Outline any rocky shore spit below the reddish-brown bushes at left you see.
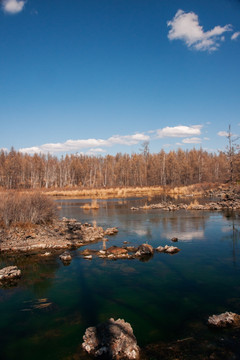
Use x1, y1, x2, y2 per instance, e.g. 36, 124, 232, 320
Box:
0, 218, 118, 252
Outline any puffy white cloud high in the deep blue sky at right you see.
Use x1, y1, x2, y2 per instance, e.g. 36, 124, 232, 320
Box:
167, 10, 232, 51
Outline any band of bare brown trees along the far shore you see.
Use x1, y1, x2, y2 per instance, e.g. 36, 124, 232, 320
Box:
0, 146, 240, 189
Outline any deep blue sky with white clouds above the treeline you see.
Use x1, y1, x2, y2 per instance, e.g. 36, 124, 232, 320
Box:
0, 0, 240, 156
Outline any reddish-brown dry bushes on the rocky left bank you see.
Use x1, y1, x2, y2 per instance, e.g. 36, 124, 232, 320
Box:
0, 191, 57, 226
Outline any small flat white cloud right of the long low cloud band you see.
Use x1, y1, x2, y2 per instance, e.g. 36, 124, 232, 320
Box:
157, 125, 202, 138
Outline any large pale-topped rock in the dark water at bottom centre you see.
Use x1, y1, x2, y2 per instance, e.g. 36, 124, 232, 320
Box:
82, 318, 139, 360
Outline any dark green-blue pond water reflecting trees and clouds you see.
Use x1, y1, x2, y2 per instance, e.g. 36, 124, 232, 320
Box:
0, 199, 240, 360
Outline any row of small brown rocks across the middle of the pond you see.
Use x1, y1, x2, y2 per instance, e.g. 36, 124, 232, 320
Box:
80, 244, 180, 260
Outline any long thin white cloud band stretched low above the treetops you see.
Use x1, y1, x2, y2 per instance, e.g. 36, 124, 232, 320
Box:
19, 133, 150, 154
